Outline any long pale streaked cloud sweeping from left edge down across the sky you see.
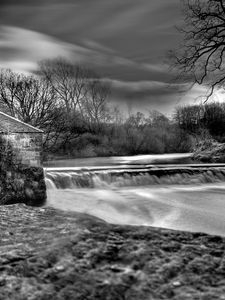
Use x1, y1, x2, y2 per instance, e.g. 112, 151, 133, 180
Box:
0, 26, 171, 78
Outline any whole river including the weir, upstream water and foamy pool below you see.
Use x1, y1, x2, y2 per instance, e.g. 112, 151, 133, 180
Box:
45, 154, 225, 236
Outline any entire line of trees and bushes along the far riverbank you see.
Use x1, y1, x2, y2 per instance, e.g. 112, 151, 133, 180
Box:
0, 59, 221, 157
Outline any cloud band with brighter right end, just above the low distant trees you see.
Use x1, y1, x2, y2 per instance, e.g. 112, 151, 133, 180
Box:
106, 79, 224, 116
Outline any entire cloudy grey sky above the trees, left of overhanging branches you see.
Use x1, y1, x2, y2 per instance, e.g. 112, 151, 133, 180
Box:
0, 0, 222, 115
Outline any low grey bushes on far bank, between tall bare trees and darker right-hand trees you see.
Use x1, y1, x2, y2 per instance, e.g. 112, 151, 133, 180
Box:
72, 111, 192, 156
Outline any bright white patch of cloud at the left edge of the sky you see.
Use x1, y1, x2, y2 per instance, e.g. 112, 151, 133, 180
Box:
0, 26, 72, 72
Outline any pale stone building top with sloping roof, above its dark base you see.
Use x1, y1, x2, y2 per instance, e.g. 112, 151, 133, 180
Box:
0, 112, 44, 166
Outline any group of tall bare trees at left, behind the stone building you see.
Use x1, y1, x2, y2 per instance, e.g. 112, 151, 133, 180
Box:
0, 59, 110, 157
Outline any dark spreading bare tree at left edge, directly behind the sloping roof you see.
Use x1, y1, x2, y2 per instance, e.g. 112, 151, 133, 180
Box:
0, 70, 66, 148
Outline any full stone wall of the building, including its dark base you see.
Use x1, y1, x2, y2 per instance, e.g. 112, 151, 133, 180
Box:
0, 133, 46, 206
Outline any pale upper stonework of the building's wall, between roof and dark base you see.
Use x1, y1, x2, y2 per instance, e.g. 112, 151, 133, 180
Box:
2, 133, 42, 166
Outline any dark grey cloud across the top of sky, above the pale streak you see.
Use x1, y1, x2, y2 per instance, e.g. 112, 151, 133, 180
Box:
1, 0, 179, 62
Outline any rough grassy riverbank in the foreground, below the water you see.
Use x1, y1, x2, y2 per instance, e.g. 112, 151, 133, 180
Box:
0, 204, 225, 300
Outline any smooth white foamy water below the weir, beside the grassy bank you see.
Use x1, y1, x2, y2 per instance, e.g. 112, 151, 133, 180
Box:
47, 185, 225, 236
